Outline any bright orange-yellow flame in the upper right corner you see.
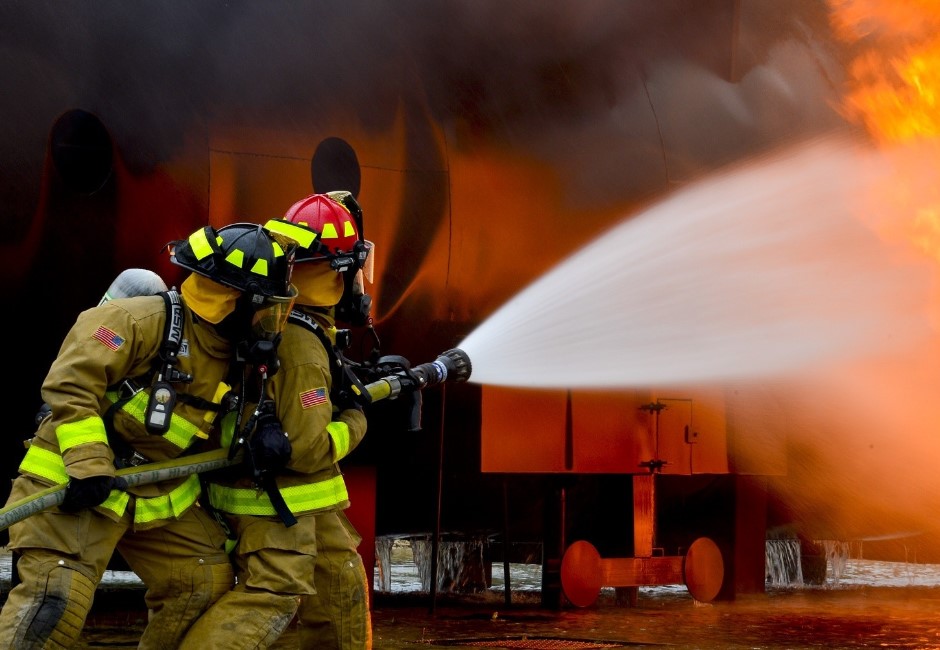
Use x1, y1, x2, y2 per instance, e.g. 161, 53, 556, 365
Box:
829, 0, 940, 261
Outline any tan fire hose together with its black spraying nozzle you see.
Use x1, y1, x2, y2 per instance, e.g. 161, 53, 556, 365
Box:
0, 348, 471, 530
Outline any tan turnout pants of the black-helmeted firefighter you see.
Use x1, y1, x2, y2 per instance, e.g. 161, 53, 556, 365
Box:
0, 470, 233, 650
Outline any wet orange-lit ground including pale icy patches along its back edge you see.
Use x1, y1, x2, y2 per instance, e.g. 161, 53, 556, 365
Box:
0, 557, 940, 650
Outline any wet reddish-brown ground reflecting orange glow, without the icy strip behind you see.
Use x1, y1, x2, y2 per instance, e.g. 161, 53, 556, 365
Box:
70, 587, 940, 650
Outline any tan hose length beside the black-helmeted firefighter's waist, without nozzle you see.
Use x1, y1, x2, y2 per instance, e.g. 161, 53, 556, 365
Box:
0, 449, 242, 530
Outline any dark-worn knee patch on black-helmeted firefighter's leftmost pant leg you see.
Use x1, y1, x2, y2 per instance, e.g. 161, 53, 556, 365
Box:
22, 565, 96, 648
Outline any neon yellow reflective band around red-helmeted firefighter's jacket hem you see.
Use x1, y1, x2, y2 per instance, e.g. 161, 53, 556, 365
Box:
209, 475, 349, 516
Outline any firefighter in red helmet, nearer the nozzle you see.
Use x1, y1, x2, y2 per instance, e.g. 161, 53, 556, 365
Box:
182, 192, 372, 650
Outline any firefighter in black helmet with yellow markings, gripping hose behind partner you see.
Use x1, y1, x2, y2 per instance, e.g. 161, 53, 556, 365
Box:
0, 224, 296, 649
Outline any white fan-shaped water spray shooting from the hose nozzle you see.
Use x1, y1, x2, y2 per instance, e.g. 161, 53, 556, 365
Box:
458, 136, 929, 388
